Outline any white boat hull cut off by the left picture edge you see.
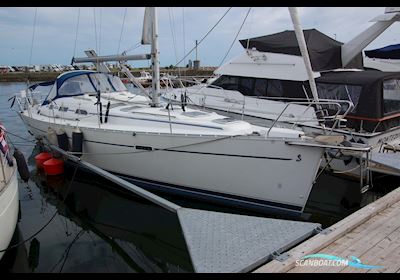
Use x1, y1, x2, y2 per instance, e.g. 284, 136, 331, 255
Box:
0, 122, 19, 259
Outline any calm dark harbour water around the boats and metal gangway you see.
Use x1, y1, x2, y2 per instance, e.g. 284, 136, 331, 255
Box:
0, 83, 396, 272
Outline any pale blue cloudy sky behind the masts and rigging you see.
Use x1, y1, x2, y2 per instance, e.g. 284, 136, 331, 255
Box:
0, 7, 400, 67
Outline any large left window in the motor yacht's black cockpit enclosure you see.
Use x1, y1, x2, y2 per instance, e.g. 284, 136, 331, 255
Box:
317, 83, 362, 114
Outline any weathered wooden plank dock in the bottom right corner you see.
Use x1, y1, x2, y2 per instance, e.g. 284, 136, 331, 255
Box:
255, 187, 400, 273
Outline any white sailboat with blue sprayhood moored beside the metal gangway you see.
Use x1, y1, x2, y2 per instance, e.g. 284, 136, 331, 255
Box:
18, 8, 354, 213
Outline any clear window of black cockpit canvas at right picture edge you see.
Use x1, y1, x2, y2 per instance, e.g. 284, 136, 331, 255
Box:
383, 79, 400, 115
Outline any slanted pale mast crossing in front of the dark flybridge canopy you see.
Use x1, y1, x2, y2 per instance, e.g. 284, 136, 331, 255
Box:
289, 7, 319, 104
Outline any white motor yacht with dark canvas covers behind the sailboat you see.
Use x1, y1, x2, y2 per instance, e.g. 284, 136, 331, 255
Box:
163, 8, 400, 177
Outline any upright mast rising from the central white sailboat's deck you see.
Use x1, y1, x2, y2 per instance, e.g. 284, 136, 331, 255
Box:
151, 7, 160, 107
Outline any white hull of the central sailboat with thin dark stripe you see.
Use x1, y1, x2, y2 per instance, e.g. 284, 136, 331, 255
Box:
21, 114, 322, 212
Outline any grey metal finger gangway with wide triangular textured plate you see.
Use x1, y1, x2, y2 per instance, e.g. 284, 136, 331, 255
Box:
49, 145, 321, 273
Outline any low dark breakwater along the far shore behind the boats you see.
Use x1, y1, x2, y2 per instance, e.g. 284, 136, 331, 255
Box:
0, 67, 216, 83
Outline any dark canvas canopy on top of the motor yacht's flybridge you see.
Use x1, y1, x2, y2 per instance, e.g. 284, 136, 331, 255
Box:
239, 29, 363, 71
